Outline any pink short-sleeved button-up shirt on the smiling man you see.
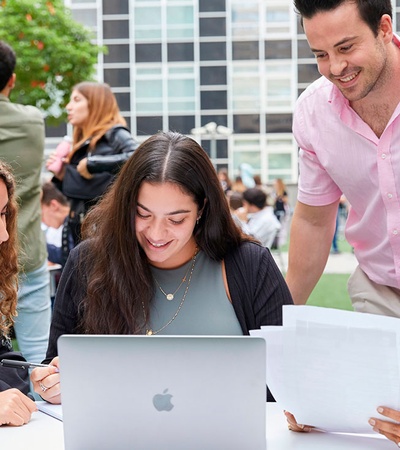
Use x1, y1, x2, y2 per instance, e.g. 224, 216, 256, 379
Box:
293, 37, 400, 288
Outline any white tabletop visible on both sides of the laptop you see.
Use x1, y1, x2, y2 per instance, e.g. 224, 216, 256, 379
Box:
0, 403, 396, 450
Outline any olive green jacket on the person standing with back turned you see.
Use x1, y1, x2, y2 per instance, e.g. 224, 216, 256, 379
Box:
0, 94, 47, 273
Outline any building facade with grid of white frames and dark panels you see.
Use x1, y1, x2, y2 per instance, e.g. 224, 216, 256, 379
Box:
54, 0, 400, 183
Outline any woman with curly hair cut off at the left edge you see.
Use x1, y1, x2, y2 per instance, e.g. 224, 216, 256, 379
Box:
0, 161, 37, 426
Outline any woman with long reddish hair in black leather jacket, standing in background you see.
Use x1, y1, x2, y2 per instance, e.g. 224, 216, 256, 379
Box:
46, 81, 137, 245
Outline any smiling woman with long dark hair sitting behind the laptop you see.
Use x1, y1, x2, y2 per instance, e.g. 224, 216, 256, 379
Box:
31, 129, 292, 403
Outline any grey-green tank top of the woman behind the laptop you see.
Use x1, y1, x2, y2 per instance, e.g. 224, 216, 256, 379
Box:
150, 251, 243, 336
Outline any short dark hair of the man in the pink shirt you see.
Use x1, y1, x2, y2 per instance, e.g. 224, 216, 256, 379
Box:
294, 0, 393, 36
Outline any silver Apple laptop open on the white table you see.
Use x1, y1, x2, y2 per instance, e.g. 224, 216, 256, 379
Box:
58, 335, 266, 450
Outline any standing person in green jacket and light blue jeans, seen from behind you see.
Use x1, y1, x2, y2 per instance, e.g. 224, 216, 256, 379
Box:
0, 42, 51, 368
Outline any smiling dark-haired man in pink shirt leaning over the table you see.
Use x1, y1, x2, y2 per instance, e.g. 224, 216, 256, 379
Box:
286, 0, 400, 317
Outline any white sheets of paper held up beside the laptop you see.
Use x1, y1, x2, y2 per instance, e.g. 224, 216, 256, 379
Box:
251, 306, 400, 433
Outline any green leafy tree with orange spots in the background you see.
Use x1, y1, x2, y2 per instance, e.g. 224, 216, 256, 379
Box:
0, 0, 105, 125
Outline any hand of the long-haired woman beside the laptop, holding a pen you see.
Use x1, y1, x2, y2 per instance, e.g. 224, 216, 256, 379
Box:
31, 356, 61, 404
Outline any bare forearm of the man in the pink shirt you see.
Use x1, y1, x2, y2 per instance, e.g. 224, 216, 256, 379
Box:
286, 200, 339, 305
